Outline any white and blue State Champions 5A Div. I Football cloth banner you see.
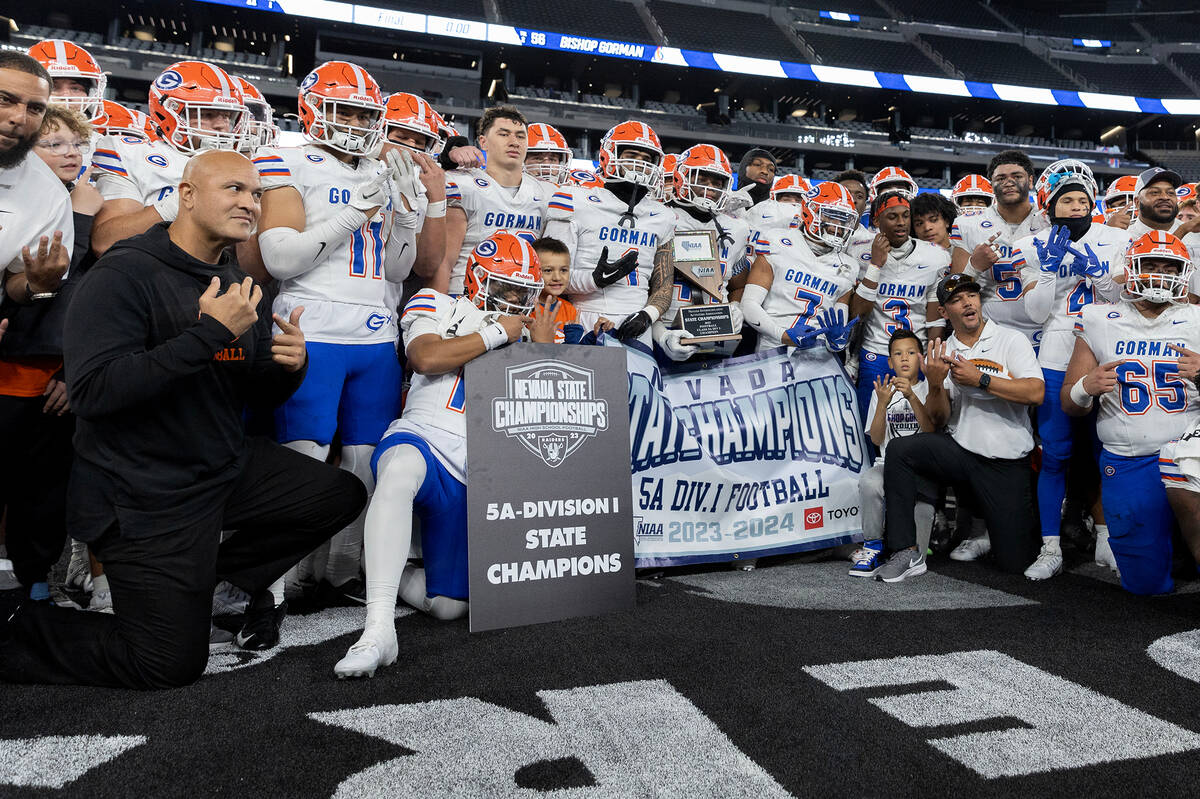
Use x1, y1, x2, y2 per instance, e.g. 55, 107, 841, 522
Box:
626, 348, 870, 567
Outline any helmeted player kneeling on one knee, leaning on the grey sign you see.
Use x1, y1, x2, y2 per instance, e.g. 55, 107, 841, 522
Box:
334, 233, 542, 679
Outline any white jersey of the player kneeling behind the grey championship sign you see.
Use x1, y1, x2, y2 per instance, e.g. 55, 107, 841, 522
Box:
388, 289, 499, 482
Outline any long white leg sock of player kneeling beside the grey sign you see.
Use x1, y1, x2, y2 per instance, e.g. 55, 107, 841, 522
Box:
362, 444, 426, 633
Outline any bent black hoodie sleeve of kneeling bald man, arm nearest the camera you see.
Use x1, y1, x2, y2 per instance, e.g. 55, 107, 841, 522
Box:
62, 269, 233, 419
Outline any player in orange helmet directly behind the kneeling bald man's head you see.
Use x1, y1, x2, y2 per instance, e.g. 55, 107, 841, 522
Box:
91, 61, 248, 253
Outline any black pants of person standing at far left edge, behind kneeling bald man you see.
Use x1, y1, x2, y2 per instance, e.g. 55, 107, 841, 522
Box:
0, 396, 74, 587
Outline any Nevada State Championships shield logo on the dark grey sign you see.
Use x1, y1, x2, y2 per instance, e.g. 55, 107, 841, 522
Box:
492, 361, 608, 467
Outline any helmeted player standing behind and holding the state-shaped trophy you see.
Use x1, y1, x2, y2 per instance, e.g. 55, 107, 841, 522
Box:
654, 144, 750, 361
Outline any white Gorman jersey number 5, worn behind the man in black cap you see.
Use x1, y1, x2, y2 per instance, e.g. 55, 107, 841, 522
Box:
950, 205, 1050, 347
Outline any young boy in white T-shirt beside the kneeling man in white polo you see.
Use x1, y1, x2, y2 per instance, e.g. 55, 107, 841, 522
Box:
850, 328, 934, 577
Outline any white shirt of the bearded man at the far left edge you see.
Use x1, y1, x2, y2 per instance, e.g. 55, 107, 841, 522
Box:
0, 152, 74, 278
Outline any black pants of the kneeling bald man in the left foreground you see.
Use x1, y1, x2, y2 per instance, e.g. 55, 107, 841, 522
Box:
0, 439, 367, 689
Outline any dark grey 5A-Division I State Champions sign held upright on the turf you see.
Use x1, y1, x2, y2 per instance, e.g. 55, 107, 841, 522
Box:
464, 343, 634, 632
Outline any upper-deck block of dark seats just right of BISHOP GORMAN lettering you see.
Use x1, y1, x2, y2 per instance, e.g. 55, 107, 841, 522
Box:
647, 0, 803, 61
